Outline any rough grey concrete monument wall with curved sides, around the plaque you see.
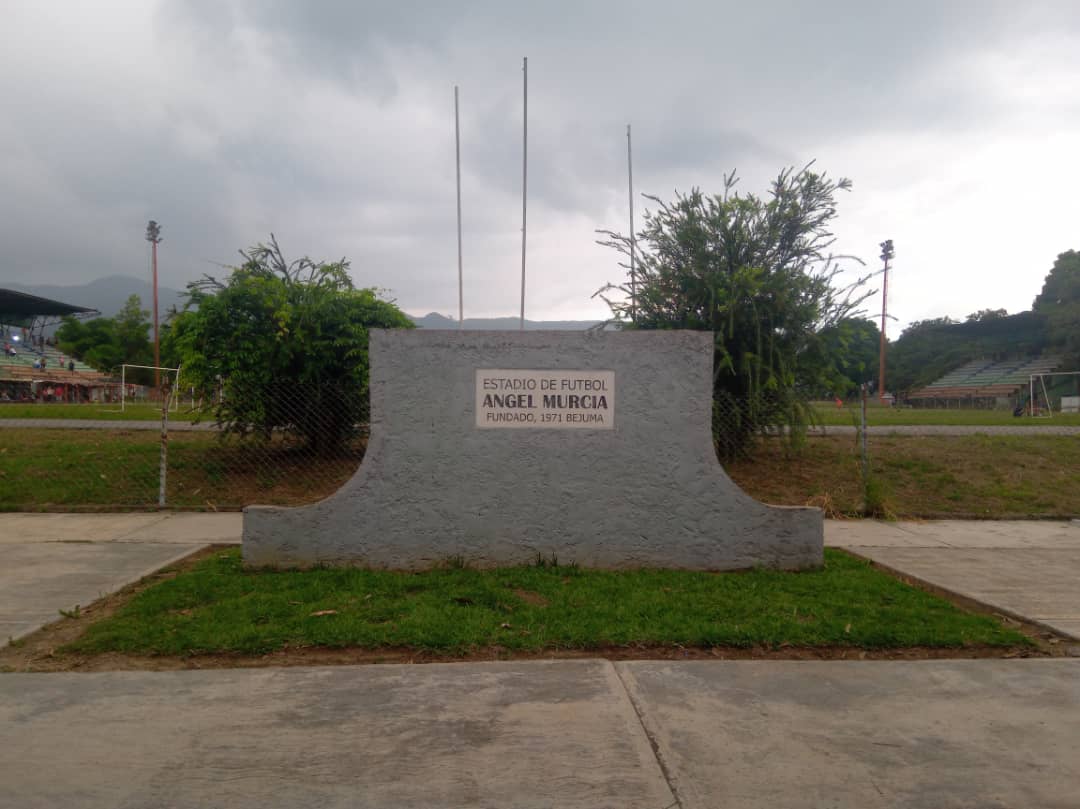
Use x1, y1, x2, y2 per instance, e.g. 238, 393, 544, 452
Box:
243, 331, 823, 570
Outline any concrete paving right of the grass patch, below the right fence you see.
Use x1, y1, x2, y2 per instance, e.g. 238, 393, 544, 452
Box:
826, 521, 1080, 639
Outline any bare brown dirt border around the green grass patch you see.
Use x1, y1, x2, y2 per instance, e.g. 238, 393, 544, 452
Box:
0, 547, 1069, 672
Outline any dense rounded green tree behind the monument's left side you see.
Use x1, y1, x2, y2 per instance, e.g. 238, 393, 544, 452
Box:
170, 235, 413, 451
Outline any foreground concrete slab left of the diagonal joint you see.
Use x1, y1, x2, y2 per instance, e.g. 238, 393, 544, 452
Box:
0, 661, 674, 809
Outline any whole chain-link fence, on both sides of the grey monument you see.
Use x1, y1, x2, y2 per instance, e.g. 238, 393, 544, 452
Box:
0, 381, 1080, 517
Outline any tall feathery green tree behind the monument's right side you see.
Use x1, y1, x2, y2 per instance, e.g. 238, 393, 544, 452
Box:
598, 166, 869, 455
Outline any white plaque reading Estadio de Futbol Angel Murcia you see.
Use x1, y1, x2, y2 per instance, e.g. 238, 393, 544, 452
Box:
476, 368, 615, 430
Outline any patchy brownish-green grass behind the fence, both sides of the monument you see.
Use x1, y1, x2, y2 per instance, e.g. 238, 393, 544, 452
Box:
0, 428, 1080, 518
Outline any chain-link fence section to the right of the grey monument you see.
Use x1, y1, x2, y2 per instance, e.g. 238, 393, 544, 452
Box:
714, 391, 1080, 520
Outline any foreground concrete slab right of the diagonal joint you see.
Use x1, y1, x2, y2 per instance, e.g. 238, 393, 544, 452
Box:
616, 659, 1080, 809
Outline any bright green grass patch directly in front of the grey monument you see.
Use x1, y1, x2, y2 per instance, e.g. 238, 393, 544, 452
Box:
63, 549, 1030, 656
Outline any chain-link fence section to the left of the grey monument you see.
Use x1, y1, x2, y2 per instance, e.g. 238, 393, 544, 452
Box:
0, 382, 367, 510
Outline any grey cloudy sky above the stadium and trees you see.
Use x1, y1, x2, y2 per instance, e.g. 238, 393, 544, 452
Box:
0, 0, 1080, 331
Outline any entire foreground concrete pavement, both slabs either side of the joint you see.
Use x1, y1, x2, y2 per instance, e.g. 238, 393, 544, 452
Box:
0, 659, 1080, 809
